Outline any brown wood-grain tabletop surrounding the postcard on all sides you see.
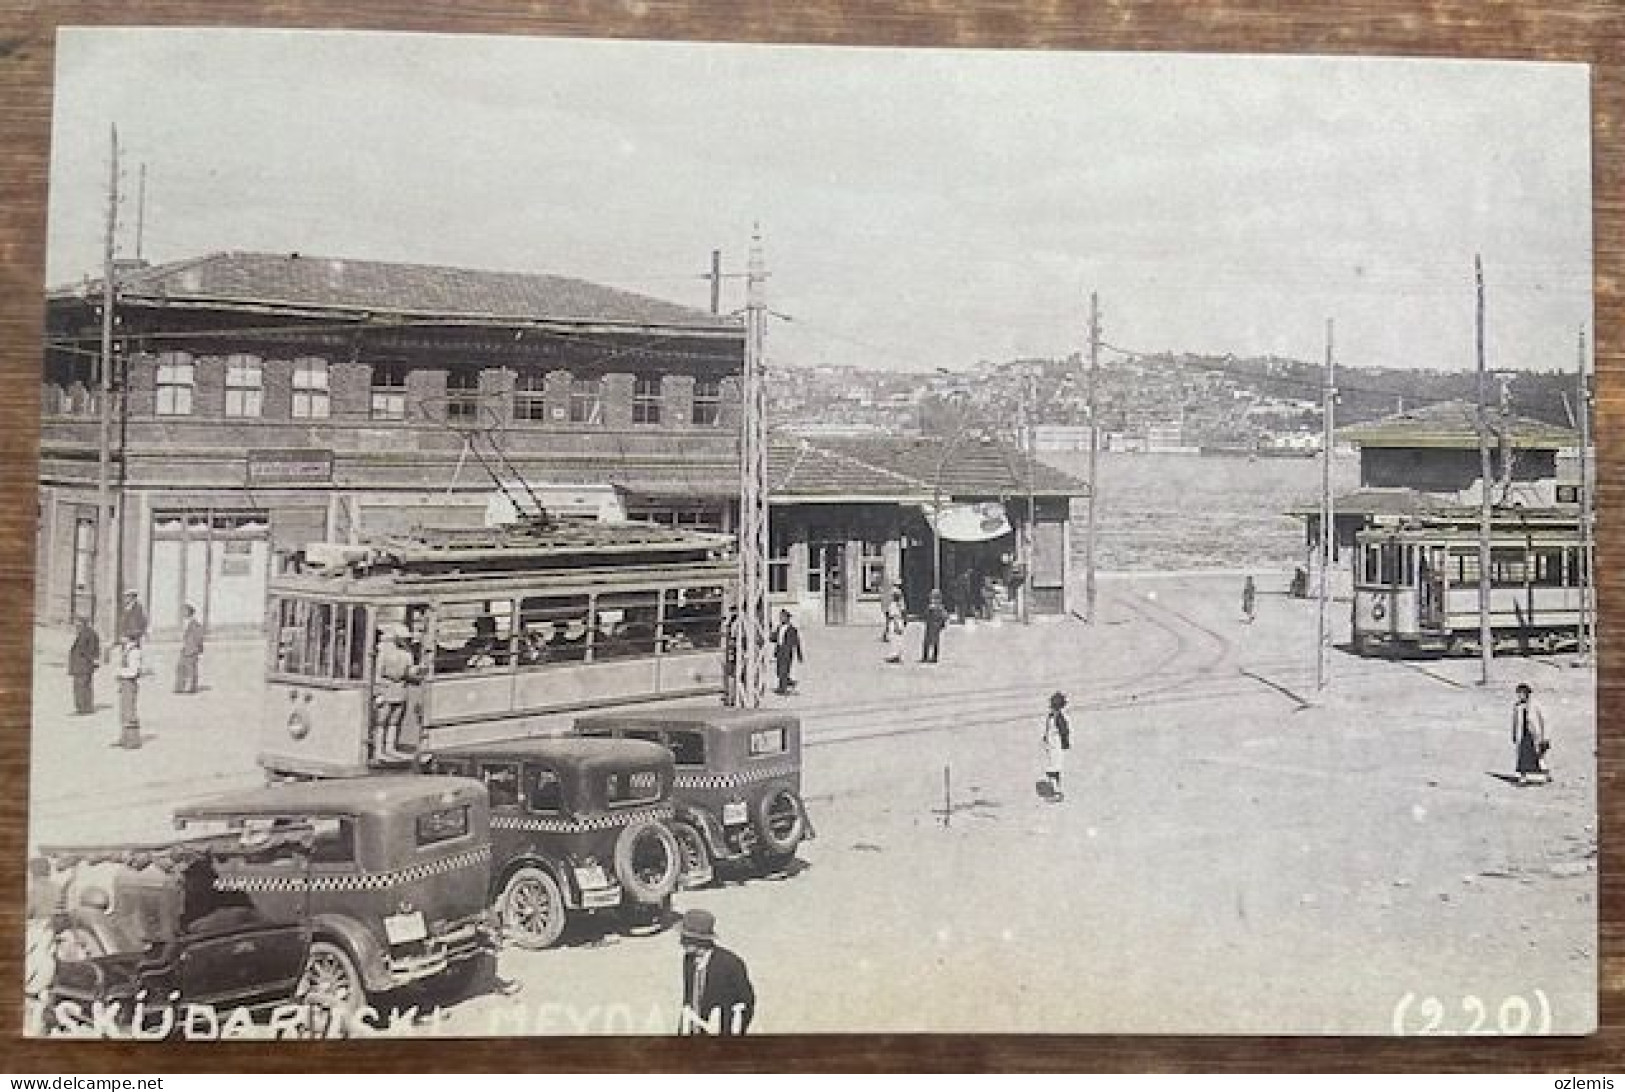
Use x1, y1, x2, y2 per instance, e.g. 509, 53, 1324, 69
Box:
0, 0, 1625, 1074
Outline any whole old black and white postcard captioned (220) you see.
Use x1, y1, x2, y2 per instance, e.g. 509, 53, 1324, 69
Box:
22, 28, 1599, 1050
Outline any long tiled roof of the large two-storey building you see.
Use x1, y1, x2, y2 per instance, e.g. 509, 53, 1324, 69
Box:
63, 252, 743, 330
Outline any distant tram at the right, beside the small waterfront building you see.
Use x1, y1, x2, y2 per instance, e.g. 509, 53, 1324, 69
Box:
1354, 512, 1588, 655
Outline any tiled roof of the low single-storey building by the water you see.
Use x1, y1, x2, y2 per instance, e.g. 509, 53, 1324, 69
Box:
767, 437, 1089, 501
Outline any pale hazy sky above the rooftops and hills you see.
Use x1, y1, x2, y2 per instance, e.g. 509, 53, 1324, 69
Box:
47, 28, 1593, 371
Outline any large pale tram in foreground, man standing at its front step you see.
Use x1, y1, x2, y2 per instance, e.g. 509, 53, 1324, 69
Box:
258, 518, 738, 777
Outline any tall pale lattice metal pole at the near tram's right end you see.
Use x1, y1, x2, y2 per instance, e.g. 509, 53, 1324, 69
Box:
734, 228, 770, 709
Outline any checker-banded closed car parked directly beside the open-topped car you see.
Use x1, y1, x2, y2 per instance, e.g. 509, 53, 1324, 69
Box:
176, 774, 494, 1011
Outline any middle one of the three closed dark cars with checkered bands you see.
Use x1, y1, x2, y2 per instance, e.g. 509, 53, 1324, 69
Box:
427, 738, 681, 949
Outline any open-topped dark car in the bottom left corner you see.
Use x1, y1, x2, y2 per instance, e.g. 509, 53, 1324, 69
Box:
28, 830, 310, 1037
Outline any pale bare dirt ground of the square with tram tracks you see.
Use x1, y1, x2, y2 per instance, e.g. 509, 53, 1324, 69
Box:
33, 575, 1597, 1035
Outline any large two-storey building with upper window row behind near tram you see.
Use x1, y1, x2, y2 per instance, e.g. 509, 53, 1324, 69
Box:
37, 254, 744, 634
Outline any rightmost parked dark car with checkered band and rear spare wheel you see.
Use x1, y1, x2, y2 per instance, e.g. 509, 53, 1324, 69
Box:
575, 707, 814, 887
